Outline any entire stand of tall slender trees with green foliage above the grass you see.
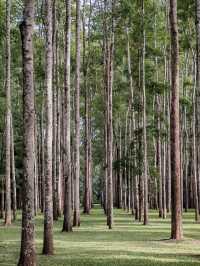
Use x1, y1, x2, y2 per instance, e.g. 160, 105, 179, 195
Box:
0, 0, 200, 265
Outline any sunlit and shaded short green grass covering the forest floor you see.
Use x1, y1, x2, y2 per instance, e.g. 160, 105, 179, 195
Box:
0, 208, 200, 266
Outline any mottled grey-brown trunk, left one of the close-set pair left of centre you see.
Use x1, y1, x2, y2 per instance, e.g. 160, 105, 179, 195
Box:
63, 0, 72, 232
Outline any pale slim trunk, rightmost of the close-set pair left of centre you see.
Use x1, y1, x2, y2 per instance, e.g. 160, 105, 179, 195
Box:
73, 0, 81, 226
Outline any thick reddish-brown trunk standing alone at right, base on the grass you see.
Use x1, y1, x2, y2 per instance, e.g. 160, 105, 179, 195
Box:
170, 0, 183, 240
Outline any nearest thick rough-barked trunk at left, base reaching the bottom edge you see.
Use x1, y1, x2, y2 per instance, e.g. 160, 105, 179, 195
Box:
18, 0, 36, 266
